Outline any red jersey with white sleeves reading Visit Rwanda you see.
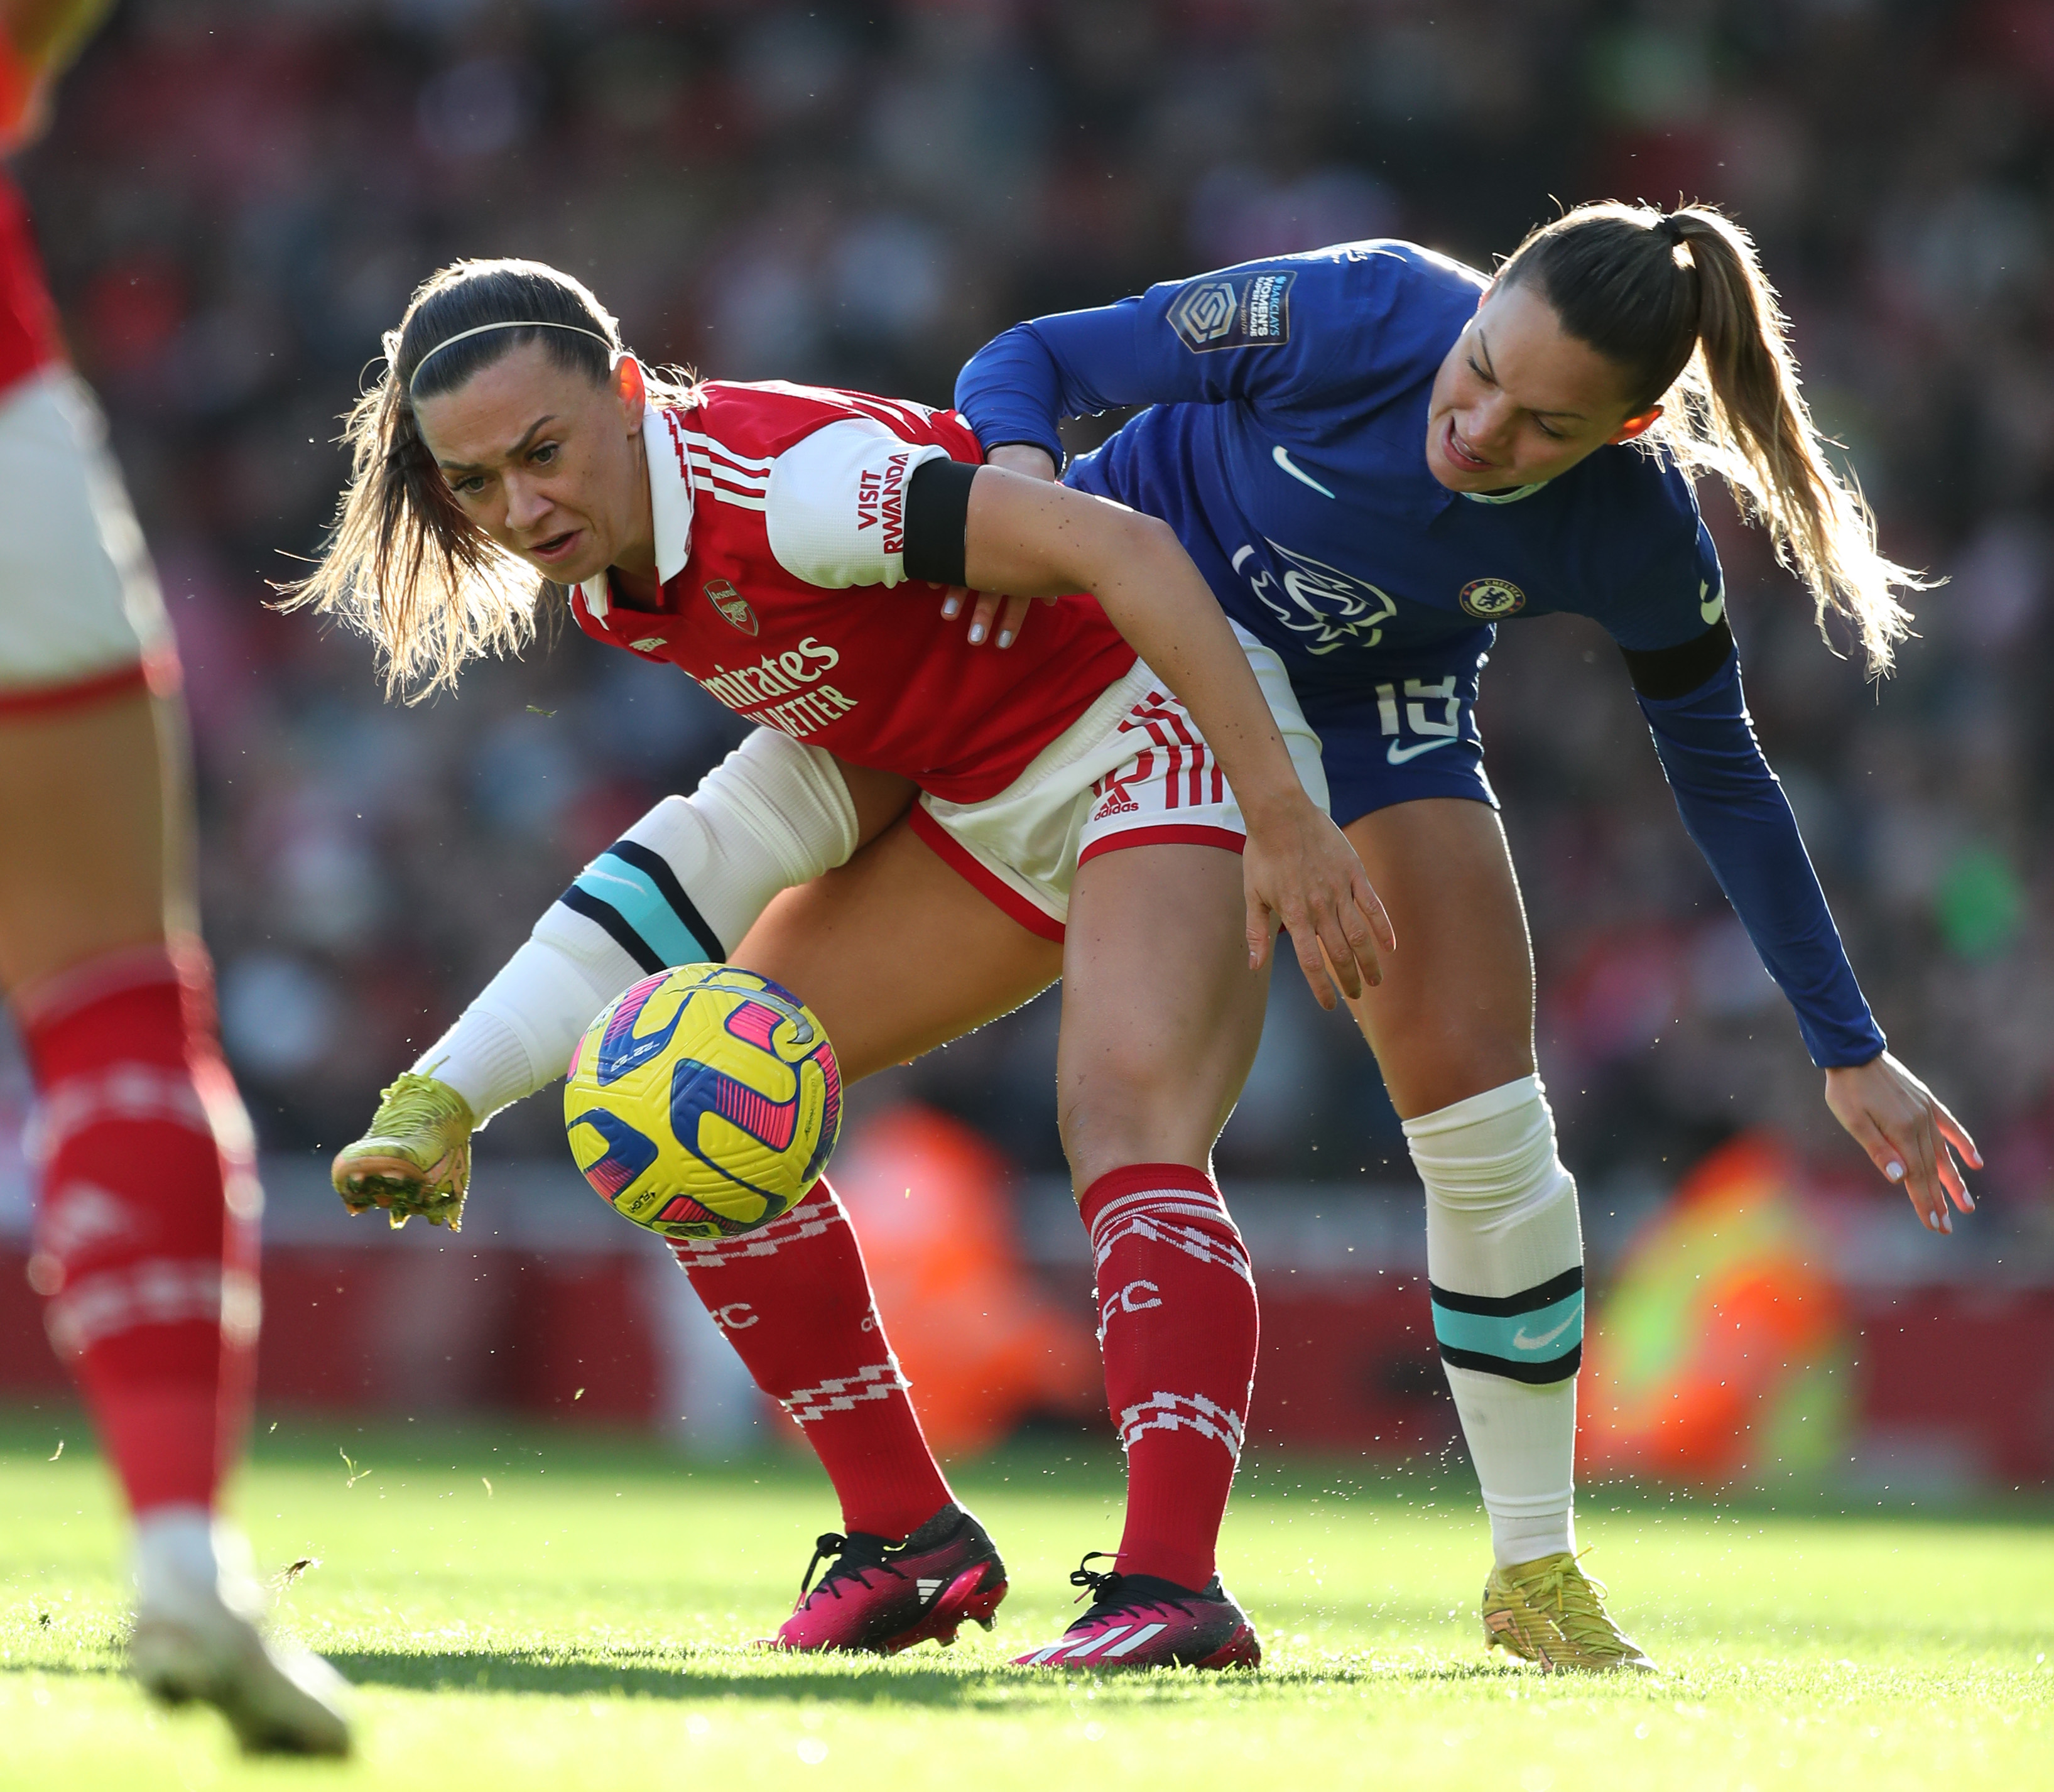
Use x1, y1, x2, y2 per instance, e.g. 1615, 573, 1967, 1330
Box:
571, 380, 1134, 803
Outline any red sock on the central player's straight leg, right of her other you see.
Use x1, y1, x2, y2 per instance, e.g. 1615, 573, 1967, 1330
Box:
1080, 1163, 1255, 1588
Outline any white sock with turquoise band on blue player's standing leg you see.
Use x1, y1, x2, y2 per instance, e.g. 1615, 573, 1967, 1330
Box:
1405, 1077, 1584, 1568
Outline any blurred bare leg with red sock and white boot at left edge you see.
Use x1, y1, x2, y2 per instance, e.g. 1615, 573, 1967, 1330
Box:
0, 682, 349, 1753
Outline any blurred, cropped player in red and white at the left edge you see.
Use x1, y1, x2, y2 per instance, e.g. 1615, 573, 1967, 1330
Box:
0, 0, 349, 1755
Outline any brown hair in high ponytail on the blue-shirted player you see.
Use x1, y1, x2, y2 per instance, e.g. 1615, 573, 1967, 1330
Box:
1497, 202, 1935, 674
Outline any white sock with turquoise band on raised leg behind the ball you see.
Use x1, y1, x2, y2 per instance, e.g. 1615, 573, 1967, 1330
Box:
413, 727, 857, 1126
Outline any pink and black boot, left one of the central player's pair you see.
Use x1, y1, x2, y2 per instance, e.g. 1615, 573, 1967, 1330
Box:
762, 1504, 1006, 1654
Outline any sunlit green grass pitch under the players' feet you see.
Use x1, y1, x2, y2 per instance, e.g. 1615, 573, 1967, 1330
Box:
0, 1414, 2054, 1792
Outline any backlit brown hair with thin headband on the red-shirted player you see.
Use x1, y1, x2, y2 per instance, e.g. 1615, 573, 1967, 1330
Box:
280, 261, 688, 701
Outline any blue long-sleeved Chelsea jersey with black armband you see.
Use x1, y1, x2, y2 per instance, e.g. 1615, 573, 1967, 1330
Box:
955, 241, 1884, 1065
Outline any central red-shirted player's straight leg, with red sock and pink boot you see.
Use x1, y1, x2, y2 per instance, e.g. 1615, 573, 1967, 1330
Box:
1021, 845, 1269, 1669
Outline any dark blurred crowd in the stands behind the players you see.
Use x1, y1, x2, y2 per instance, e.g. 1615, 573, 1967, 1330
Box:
8, 0, 2054, 1225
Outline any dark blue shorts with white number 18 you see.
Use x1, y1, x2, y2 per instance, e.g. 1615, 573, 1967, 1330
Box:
1286, 639, 1497, 828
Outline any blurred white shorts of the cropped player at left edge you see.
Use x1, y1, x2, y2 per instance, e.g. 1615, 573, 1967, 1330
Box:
0, 368, 177, 717
